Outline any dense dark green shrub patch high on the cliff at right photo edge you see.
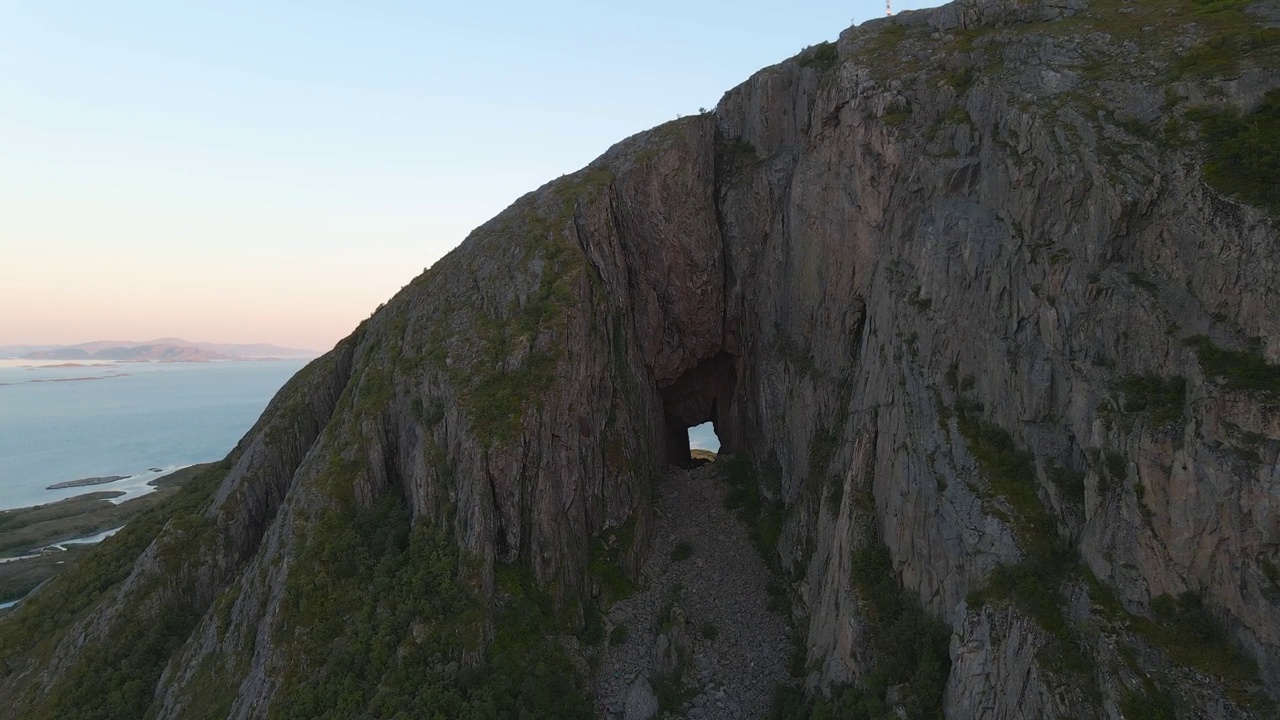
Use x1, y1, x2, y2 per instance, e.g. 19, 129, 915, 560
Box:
1188, 89, 1280, 215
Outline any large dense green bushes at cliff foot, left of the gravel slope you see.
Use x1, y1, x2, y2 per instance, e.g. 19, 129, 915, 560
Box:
269, 484, 590, 720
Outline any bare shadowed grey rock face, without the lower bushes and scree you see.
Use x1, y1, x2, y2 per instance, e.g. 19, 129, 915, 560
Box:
5, 0, 1280, 717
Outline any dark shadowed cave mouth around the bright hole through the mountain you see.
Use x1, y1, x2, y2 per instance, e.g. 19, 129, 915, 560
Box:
662, 352, 736, 468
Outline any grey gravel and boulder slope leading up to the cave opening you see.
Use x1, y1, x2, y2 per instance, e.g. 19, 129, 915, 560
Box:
595, 465, 792, 720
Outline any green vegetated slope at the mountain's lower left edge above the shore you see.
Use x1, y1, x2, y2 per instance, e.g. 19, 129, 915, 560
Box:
0, 464, 227, 720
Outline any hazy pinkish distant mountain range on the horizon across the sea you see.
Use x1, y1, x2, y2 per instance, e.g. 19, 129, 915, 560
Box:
0, 337, 320, 363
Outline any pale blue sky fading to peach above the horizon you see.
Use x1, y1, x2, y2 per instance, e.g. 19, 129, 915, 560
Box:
0, 0, 938, 348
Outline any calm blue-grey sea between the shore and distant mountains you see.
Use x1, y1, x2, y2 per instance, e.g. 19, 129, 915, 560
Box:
0, 360, 306, 510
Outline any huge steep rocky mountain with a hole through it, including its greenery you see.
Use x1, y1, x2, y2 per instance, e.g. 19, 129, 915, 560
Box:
0, 0, 1280, 719
